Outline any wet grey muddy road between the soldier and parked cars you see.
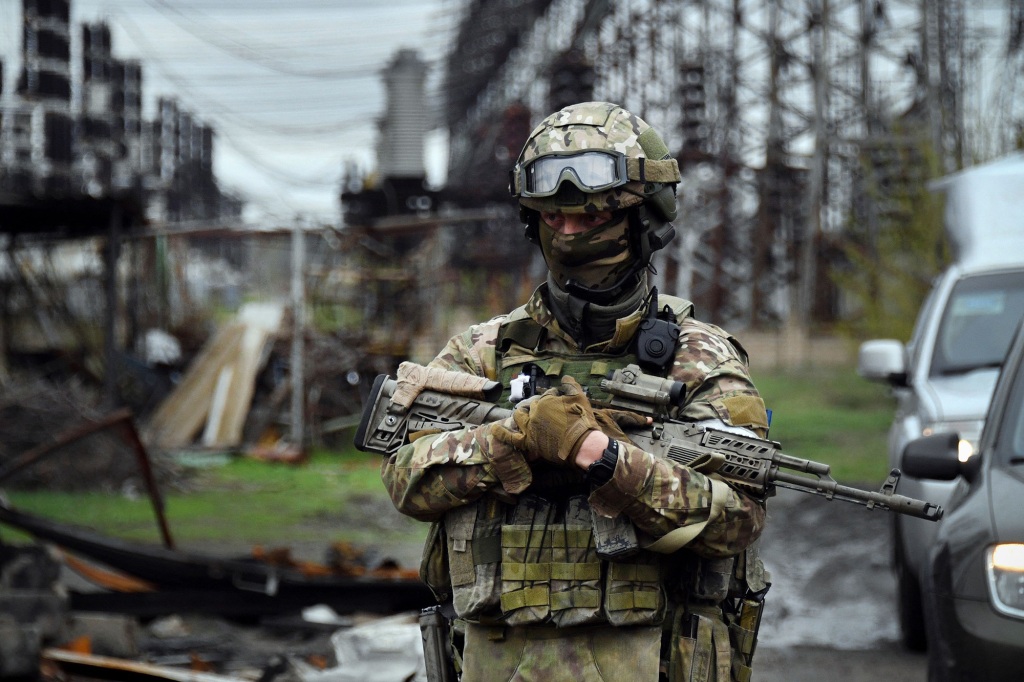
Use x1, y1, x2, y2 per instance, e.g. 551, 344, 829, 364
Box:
754, 491, 927, 682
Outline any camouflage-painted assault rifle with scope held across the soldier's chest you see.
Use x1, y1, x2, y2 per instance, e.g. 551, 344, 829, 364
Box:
355, 363, 943, 521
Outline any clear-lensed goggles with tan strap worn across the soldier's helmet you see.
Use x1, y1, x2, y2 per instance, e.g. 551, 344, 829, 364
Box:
511, 150, 679, 198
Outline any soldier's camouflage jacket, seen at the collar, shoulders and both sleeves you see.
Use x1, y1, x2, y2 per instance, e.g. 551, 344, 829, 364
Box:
381, 285, 767, 557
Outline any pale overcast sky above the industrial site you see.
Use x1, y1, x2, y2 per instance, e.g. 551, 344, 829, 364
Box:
0, 0, 462, 223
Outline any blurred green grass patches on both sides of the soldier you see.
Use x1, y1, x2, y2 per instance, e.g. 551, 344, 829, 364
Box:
4, 360, 894, 546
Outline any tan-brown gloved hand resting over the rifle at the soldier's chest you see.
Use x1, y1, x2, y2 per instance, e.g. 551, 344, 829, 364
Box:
492, 377, 601, 466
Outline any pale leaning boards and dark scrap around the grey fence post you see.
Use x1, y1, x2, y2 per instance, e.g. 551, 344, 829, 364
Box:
144, 304, 397, 459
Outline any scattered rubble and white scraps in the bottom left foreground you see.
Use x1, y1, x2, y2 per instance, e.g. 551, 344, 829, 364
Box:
0, 543, 425, 682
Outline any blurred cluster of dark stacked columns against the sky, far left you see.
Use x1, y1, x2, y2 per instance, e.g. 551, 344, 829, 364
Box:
0, 0, 239, 229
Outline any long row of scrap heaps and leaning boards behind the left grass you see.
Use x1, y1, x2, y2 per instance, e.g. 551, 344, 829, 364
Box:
0, 304, 397, 494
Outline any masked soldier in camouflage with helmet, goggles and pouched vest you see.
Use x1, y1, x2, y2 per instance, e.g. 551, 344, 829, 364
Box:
382, 102, 768, 682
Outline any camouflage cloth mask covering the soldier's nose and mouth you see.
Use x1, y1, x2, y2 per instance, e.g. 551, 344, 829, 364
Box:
538, 216, 633, 289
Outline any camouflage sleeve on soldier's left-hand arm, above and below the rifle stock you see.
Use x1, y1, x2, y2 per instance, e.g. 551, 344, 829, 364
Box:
381, 321, 532, 520
